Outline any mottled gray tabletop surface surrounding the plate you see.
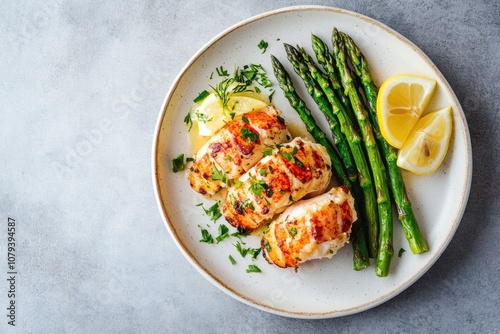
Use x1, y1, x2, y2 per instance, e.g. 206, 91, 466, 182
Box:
0, 0, 500, 333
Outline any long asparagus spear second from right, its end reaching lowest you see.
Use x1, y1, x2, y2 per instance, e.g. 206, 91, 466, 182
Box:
332, 28, 394, 277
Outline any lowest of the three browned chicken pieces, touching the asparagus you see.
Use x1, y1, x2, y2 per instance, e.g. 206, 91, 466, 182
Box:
261, 187, 357, 268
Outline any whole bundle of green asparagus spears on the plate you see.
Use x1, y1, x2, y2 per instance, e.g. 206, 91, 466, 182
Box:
271, 24, 428, 277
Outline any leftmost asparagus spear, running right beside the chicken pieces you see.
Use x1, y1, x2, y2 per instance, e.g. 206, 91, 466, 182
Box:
271, 55, 370, 270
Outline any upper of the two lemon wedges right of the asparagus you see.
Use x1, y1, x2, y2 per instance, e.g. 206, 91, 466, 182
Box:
377, 74, 436, 148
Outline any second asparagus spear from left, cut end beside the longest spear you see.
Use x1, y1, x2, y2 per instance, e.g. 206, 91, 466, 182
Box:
287, 41, 378, 257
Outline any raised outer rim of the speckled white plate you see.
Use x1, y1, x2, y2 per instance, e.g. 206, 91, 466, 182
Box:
151, 5, 472, 319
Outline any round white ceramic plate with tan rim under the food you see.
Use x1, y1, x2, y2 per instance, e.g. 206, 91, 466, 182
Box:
152, 6, 472, 318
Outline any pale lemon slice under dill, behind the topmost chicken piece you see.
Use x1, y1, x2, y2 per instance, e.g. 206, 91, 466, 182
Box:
192, 93, 267, 136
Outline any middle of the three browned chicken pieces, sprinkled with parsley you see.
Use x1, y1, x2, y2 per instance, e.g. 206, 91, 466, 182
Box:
222, 137, 332, 231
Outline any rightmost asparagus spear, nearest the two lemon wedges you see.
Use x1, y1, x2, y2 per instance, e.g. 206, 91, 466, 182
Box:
341, 33, 429, 254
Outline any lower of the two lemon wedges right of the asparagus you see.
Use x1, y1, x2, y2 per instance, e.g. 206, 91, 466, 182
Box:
397, 107, 453, 175
